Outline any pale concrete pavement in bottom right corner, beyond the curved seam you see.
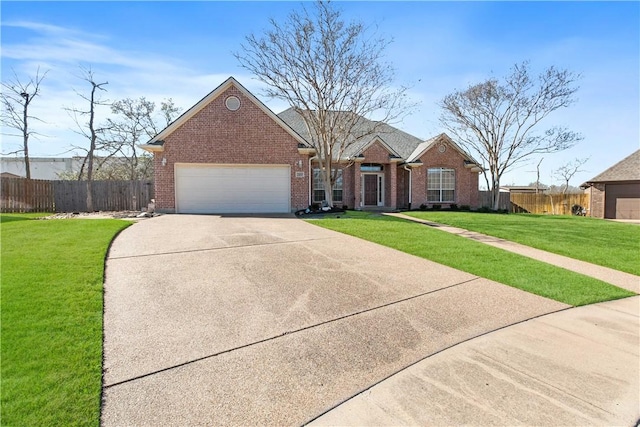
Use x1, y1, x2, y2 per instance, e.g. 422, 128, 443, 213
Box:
309, 296, 640, 426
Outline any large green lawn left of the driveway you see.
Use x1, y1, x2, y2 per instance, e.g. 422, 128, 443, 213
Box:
0, 214, 130, 426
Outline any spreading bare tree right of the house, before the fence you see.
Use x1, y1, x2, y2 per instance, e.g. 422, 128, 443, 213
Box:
440, 62, 582, 209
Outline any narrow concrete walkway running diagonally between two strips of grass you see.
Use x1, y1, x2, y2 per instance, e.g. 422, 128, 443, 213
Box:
385, 213, 640, 294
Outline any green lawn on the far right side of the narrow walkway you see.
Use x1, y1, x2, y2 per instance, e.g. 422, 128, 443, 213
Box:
407, 212, 640, 276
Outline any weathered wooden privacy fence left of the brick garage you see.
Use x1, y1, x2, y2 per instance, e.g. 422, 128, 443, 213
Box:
0, 178, 154, 212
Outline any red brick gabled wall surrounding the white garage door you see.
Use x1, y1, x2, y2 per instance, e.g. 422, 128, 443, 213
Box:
154, 86, 309, 212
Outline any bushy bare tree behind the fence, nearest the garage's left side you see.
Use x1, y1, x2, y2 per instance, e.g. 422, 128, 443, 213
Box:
105, 97, 180, 180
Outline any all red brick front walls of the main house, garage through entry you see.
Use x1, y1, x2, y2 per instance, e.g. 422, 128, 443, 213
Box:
145, 79, 478, 212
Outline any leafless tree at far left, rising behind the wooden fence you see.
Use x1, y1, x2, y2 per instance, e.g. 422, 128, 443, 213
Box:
0, 67, 48, 179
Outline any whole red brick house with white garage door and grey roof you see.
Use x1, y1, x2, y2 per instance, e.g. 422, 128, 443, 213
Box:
141, 77, 481, 213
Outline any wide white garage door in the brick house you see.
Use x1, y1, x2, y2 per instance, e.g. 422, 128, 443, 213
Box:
175, 164, 291, 213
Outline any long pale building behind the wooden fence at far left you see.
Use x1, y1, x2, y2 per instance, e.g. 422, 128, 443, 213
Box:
0, 157, 82, 180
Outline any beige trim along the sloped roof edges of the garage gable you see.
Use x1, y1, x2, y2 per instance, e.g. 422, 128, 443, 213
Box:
140, 77, 309, 151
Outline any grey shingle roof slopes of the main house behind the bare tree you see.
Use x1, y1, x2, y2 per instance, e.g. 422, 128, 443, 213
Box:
278, 108, 422, 159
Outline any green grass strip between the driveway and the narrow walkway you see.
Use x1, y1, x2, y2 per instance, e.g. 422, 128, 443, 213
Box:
309, 211, 635, 306
